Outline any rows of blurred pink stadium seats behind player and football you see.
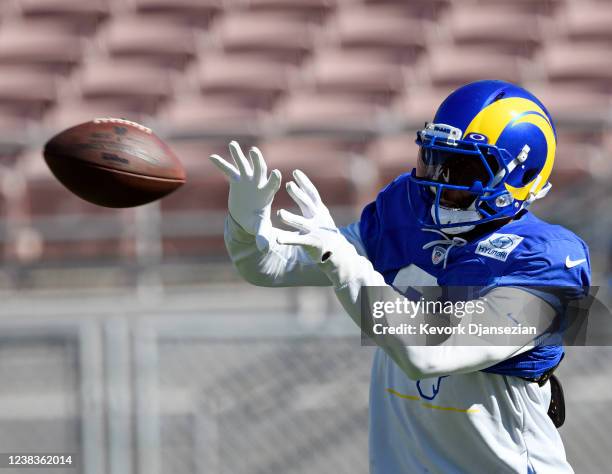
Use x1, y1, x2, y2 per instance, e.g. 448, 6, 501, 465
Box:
0, 0, 612, 262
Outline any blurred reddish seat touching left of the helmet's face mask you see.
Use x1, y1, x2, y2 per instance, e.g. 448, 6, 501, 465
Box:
366, 133, 417, 188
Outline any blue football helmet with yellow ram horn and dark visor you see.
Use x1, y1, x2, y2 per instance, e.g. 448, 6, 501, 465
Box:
410, 80, 557, 234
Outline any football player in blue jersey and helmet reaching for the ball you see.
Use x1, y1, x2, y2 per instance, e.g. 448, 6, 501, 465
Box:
211, 80, 590, 474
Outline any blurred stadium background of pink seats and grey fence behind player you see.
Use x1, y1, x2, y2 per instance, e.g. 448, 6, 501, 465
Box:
0, 0, 612, 474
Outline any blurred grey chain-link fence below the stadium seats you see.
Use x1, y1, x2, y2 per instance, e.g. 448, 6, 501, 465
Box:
0, 290, 612, 474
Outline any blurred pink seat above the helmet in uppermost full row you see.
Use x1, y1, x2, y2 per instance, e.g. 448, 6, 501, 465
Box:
443, 5, 541, 56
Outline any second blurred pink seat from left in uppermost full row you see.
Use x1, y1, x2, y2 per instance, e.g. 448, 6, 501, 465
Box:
103, 17, 196, 69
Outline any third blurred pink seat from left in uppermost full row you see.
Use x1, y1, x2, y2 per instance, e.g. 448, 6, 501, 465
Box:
213, 12, 312, 64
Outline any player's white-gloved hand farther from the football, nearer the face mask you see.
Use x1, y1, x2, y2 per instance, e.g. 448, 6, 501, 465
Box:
276, 170, 350, 263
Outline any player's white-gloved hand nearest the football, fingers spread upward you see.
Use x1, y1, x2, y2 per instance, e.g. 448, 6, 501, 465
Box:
210, 141, 281, 236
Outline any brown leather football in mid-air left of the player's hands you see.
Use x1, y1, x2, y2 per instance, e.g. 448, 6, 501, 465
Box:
44, 118, 185, 207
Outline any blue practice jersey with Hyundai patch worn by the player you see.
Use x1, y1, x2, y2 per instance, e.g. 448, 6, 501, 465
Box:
360, 175, 590, 378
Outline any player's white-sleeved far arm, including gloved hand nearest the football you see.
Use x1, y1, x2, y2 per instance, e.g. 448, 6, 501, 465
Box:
210, 141, 362, 286
